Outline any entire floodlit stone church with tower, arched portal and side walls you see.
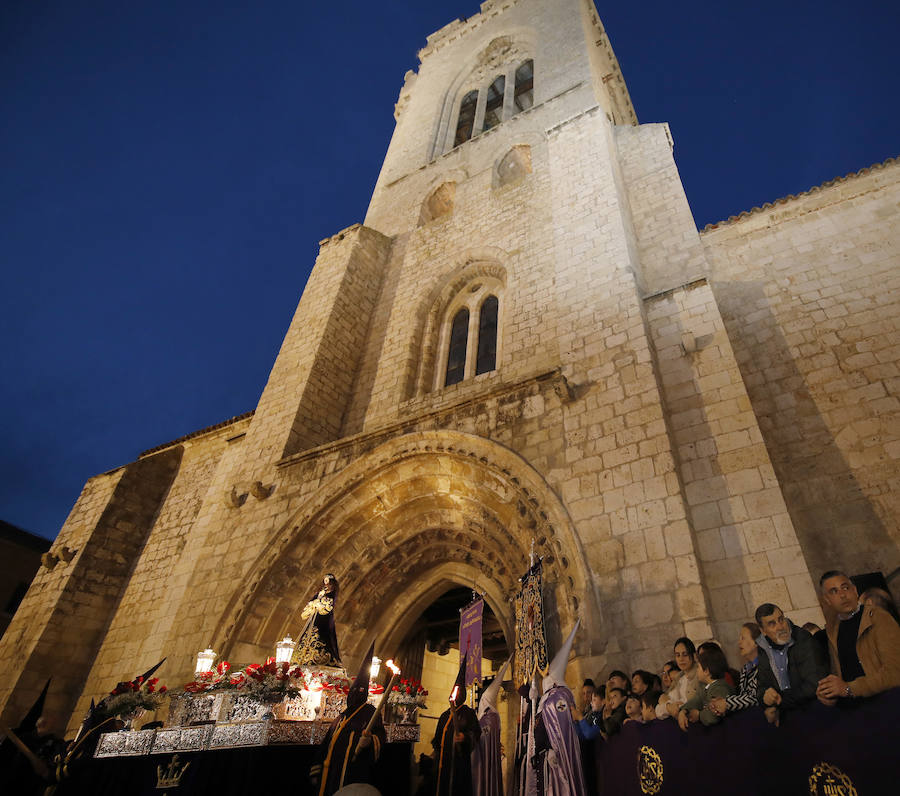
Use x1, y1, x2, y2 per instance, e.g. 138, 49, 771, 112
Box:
0, 0, 900, 726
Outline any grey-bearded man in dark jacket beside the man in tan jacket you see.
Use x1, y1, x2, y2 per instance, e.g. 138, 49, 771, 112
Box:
756, 603, 828, 724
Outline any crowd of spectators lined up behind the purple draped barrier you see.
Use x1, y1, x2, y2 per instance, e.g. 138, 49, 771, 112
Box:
574, 570, 900, 740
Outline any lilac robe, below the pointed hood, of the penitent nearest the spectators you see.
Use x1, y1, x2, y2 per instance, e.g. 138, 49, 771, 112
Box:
540, 685, 587, 796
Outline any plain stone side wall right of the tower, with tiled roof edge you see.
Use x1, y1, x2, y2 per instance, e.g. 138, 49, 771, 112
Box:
702, 160, 900, 584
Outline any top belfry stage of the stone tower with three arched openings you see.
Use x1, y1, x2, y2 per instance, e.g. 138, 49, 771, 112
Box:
366, 0, 637, 228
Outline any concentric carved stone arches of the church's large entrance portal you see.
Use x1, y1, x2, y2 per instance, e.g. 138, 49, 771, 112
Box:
216, 432, 602, 676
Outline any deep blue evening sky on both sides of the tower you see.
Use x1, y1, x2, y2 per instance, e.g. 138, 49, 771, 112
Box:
0, 0, 900, 537
